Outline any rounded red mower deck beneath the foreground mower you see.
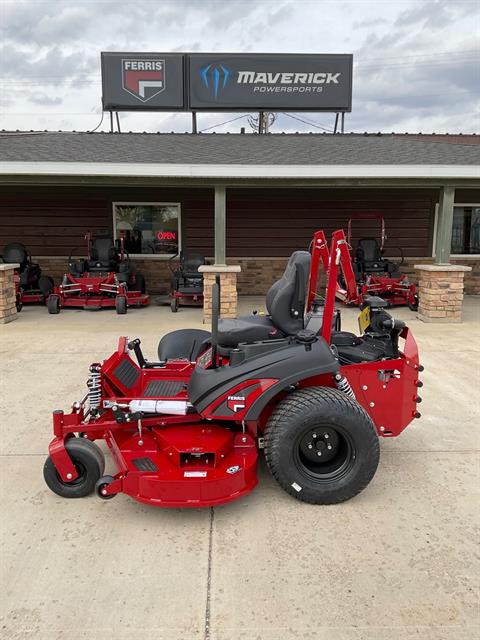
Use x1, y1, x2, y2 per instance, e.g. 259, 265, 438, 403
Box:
103, 423, 258, 507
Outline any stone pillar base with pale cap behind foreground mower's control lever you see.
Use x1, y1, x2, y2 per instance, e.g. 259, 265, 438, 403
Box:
198, 265, 240, 324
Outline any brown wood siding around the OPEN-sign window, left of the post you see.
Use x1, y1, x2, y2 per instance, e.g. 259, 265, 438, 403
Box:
0, 187, 213, 256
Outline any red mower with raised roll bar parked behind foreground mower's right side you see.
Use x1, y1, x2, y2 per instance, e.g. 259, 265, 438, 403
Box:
330, 213, 418, 311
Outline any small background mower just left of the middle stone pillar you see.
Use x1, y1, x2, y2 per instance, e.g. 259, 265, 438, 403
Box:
170, 251, 207, 313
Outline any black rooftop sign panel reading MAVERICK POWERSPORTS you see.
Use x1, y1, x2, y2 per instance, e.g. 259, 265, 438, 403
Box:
188, 53, 353, 111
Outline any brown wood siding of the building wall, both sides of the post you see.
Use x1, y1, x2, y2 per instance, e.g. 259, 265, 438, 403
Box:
0, 186, 450, 258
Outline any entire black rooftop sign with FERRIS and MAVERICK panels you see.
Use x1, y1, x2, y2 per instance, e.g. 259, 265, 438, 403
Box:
102, 53, 352, 112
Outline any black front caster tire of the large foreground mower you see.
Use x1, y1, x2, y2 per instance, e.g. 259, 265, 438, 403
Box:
43, 438, 103, 498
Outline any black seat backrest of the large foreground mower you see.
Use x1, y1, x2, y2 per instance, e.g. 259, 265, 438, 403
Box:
266, 251, 311, 335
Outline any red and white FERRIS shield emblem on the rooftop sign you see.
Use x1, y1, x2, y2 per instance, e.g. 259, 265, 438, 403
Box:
122, 58, 165, 102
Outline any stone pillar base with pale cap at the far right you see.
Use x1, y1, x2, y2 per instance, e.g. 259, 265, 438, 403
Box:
415, 264, 472, 322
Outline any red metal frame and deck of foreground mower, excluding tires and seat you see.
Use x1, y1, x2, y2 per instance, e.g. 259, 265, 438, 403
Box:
44, 231, 423, 507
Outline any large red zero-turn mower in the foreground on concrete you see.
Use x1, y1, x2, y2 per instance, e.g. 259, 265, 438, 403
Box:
44, 231, 423, 507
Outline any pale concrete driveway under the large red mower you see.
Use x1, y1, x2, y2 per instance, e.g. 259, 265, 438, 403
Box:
0, 298, 480, 640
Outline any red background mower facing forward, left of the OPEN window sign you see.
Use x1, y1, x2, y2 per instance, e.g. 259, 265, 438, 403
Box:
47, 232, 149, 314
